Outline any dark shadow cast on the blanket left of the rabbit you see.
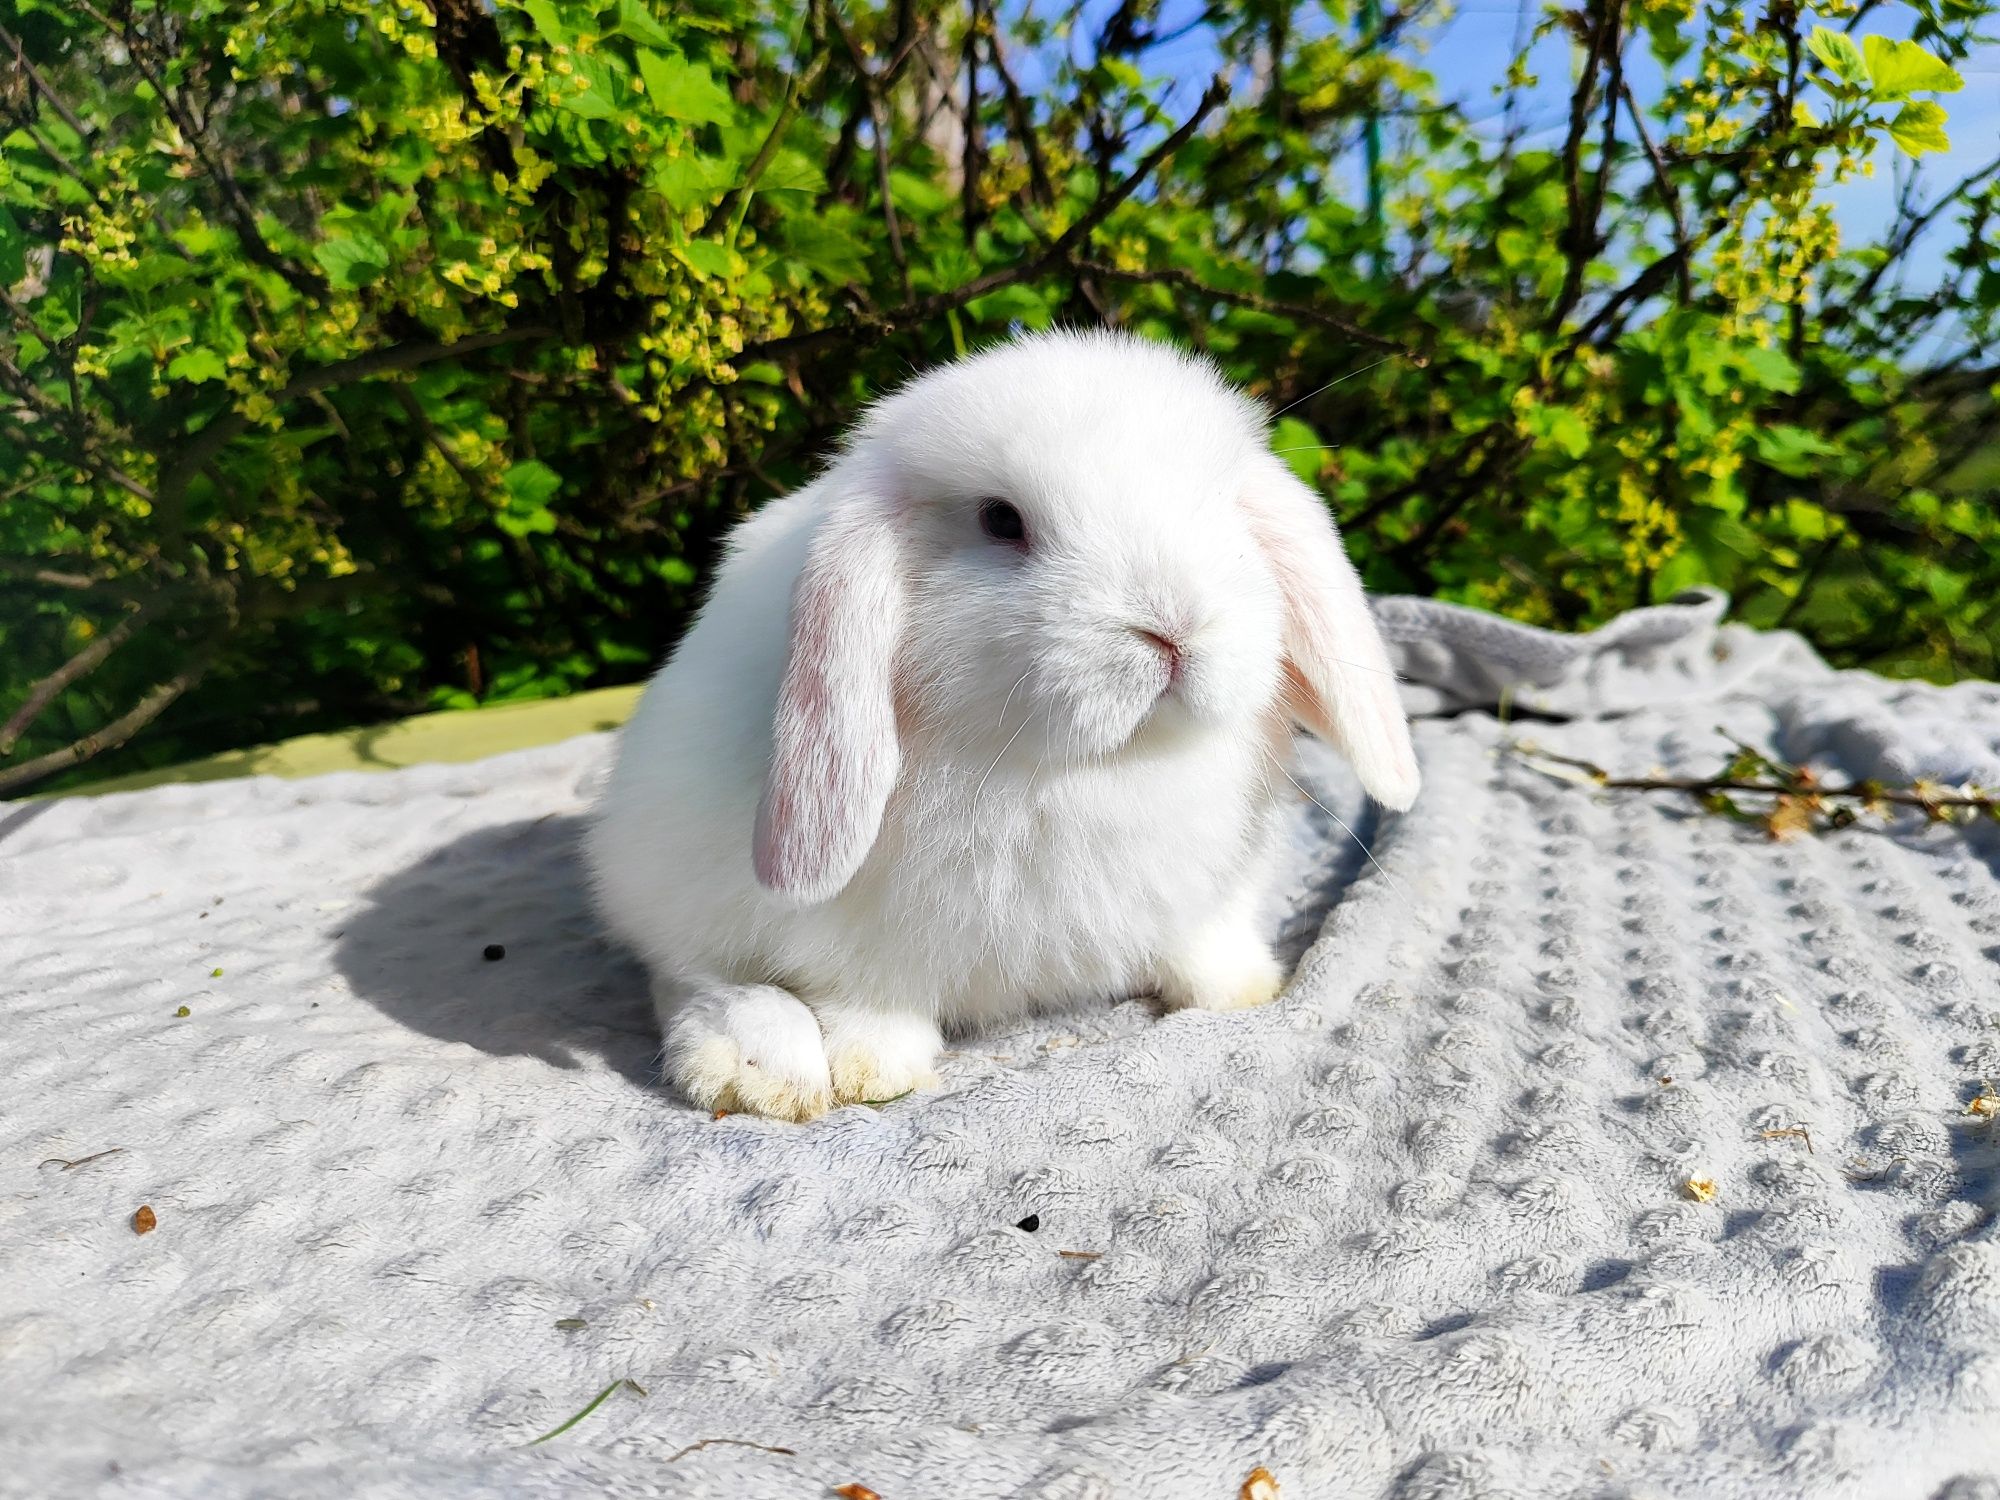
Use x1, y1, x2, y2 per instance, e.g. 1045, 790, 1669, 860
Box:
334, 816, 660, 1088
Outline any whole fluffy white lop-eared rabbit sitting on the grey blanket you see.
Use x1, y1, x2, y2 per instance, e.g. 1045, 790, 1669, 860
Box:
588, 334, 1418, 1120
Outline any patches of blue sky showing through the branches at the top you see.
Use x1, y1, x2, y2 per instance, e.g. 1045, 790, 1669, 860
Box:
1048, 0, 2000, 294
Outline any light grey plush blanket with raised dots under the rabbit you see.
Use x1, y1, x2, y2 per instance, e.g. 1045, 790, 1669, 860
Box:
0, 598, 2000, 1500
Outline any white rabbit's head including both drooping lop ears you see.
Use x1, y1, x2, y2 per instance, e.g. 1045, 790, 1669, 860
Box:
756, 334, 1418, 902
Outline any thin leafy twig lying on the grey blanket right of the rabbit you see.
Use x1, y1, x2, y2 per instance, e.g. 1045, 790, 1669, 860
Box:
1510, 728, 2000, 838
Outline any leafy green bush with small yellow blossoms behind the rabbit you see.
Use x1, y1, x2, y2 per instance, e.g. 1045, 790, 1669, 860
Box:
0, 0, 2000, 790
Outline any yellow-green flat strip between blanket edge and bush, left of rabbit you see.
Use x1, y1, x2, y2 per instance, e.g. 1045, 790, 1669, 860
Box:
68, 686, 640, 796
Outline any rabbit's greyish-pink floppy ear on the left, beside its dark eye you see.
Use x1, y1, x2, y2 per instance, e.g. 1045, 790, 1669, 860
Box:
754, 498, 904, 906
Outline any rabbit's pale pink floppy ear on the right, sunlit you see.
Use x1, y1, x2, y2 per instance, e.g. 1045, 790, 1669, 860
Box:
1242, 454, 1420, 808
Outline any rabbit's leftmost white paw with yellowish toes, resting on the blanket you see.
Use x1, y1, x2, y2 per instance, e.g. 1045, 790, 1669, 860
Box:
664, 984, 834, 1120
